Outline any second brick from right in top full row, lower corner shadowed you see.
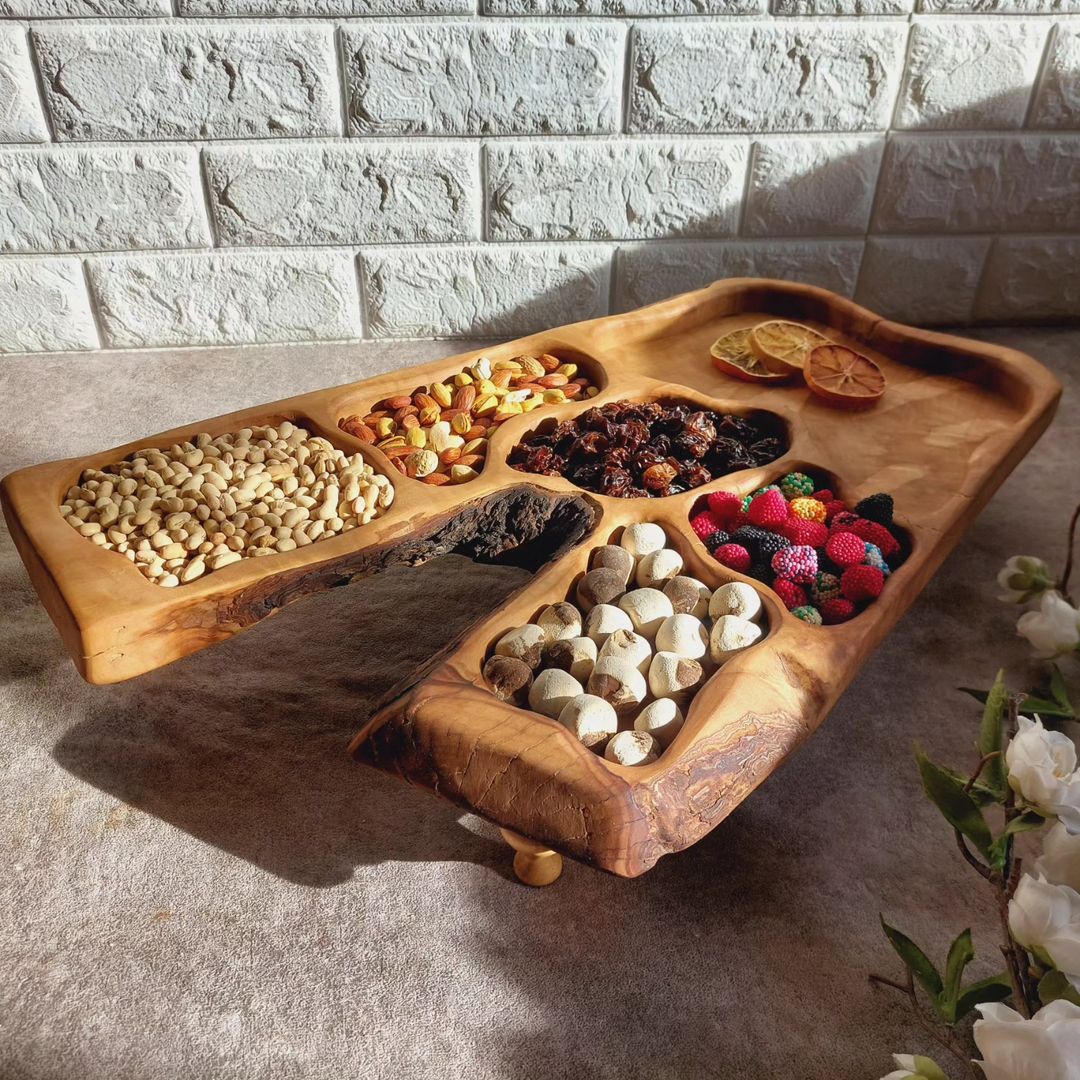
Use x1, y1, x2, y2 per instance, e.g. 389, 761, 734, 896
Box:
895, 19, 1048, 130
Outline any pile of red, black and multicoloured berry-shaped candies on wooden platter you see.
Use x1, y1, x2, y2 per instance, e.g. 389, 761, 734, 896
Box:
690, 472, 906, 626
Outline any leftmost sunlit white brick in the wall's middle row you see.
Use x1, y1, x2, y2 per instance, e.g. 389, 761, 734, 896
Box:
0, 146, 211, 252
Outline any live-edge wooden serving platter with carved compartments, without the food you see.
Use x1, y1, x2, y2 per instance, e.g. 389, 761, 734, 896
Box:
0, 279, 1061, 877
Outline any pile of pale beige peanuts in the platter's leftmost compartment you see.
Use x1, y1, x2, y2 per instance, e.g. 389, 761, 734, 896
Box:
60, 420, 394, 588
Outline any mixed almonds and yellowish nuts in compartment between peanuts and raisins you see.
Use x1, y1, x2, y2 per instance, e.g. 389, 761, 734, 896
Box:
338, 353, 597, 485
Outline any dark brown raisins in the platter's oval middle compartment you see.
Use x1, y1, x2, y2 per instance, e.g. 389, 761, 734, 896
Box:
509, 401, 786, 499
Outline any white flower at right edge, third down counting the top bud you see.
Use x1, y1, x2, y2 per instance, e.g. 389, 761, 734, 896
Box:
1005, 716, 1080, 835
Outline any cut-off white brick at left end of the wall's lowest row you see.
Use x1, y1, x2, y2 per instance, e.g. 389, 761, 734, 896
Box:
0, 258, 98, 352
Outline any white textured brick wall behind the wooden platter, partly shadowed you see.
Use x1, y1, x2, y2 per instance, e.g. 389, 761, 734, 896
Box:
0, 9, 1080, 352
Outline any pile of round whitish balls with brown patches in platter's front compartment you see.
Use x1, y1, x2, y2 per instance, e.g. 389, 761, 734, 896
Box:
484, 523, 764, 765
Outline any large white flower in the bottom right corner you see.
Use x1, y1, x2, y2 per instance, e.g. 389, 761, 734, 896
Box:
974, 1001, 1080, 1080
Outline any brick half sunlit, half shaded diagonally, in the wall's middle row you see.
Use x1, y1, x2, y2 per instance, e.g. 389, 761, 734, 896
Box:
744, 138, 885, 237
